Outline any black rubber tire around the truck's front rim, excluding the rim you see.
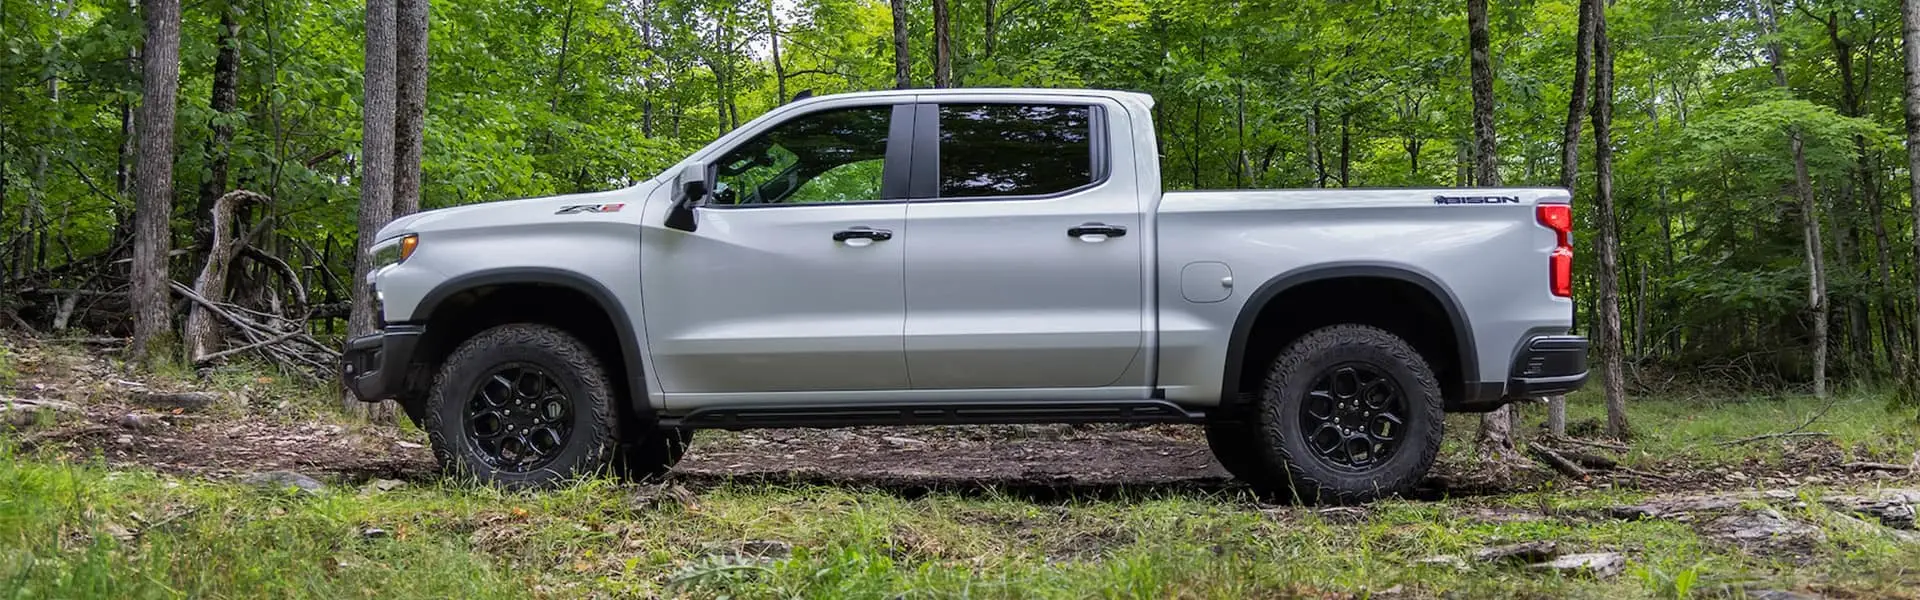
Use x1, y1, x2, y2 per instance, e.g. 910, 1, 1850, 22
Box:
424, 323, 620, 488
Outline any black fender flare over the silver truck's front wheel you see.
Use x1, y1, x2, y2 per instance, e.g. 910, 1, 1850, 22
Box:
413, 267, 653, 415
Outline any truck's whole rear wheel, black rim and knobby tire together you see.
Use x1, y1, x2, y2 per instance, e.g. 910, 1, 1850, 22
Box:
1254, 325, 1446, 504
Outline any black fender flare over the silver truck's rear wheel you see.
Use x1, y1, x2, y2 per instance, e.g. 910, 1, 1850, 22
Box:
1221, 263, 1480, 402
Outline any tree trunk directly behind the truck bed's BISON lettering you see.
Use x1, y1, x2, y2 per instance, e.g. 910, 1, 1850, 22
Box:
1467, 0, 1521, 462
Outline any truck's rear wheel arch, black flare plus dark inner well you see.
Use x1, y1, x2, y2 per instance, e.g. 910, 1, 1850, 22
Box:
1221, 263, 1480, 406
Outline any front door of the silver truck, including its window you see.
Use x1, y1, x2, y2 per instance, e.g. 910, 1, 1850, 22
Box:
641, 100, 914, 402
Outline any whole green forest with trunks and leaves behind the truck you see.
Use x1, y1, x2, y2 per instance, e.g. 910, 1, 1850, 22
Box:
0, 0, 1920, 421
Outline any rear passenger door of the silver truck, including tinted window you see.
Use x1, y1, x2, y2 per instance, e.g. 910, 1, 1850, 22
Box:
906, 94, 1150, 390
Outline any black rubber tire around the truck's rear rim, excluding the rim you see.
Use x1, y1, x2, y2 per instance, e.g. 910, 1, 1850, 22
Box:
1250, 325, 1446, 504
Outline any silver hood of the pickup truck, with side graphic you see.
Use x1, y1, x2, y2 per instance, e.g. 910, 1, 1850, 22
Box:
374, 187, 657, 242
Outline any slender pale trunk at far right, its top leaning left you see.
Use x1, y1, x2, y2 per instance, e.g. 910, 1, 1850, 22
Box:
1753, 2, 1830, 398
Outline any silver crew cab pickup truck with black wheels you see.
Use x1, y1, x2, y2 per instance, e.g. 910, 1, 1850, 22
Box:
342, 88, 1588, 502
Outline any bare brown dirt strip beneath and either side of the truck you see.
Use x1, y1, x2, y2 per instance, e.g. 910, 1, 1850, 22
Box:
0, 334, 1912, 498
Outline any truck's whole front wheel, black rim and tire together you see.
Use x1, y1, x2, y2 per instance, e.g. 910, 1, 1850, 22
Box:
426, 323, 620, 488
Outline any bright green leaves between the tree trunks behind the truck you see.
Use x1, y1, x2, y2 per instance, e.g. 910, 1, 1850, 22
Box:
11, 0, 1920, 385
